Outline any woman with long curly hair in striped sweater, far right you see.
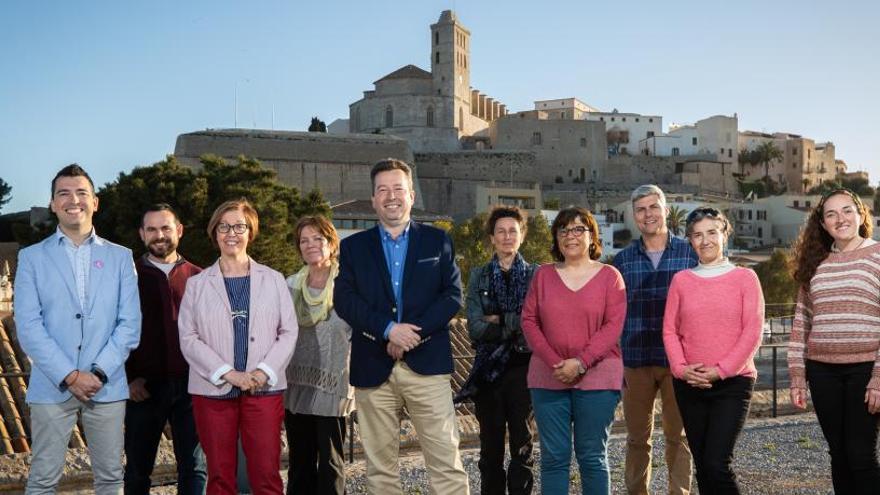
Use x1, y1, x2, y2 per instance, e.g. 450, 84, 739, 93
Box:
788, 189, 880, 494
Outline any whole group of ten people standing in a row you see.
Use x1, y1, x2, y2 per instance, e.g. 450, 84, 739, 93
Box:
15, 159, 880, 494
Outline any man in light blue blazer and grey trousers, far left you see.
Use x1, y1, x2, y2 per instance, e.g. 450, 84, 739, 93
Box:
14, 164, 141, 495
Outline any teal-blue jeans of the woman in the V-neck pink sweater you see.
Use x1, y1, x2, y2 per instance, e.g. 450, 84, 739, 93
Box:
531, 388, 620, 495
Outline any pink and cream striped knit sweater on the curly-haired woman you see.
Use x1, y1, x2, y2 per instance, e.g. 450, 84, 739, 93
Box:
788, 243, 880, 389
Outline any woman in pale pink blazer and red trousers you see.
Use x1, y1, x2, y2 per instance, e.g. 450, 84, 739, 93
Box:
178, 199, 297, 495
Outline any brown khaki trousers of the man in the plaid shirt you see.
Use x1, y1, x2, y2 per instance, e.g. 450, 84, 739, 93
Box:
623, 366, 691, 495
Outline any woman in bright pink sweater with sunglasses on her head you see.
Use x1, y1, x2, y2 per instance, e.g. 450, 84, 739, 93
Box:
663, 207, 764, 494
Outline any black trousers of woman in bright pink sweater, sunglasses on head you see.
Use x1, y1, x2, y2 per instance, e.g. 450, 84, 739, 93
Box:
673, 376, 755, 495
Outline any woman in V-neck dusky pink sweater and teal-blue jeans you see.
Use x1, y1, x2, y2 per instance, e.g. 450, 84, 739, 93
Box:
522, 207, 626, 494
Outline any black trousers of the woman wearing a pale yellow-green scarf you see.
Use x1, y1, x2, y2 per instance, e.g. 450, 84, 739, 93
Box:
284, 410, 345, 495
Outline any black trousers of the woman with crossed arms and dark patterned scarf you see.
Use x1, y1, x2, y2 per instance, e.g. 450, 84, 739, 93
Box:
474, 364, 535, 495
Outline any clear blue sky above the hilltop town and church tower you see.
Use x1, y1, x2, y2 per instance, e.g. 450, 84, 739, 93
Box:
0, 0, 880, 212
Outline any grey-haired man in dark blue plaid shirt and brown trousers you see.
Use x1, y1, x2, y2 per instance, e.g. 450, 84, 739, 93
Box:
614, 185, 697, 495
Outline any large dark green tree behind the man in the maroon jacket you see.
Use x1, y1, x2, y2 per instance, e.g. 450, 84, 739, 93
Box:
95, 155, 330, 274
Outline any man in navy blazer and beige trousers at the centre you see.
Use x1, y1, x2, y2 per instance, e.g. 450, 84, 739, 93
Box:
333, 158, 469, 495
